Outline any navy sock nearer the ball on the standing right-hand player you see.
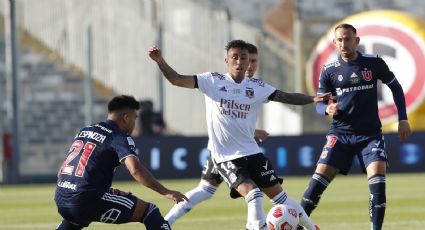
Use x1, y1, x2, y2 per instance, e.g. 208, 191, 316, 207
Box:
301, 173, 330, 216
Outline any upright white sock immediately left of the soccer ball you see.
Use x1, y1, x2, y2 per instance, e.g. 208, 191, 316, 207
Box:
245, 188, 266, 230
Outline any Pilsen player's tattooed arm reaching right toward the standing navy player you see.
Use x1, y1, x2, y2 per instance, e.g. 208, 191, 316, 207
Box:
269, 90, 332, 105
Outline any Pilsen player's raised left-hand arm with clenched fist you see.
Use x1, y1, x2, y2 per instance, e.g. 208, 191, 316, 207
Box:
149, 46, 195, 89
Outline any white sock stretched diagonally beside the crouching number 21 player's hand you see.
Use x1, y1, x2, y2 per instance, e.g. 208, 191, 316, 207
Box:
164, 180, 217, 225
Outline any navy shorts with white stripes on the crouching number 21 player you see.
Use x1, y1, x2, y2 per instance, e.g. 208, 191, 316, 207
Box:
58, 188, 138, 227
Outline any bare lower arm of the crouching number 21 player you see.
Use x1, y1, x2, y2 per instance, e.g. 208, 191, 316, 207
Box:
124, 157, 188, 203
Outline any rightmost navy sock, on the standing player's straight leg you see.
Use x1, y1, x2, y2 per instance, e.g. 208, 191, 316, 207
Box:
368, 174, 387, 230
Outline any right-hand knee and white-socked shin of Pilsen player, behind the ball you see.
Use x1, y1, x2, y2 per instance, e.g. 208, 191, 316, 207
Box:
261, 184, 316, 230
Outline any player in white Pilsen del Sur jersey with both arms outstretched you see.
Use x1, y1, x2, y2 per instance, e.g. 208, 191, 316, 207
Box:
149, 40, 330, 230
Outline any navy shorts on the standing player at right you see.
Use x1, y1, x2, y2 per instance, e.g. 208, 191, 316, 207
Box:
318, 133, 388, 175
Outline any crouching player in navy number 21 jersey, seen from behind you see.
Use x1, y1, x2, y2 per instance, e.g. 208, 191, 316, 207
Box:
55, 95, 187, 230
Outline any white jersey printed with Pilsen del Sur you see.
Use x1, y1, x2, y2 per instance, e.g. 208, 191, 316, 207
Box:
197, 72, 276, 163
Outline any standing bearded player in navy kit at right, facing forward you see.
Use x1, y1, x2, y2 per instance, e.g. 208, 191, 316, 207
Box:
301, 24, 411, 230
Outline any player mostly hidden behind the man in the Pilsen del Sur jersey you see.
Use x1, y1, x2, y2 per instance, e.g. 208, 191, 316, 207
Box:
164, 44, 269, 229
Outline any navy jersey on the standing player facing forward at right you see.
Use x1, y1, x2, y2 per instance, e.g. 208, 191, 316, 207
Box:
316, 52, 407, 133
